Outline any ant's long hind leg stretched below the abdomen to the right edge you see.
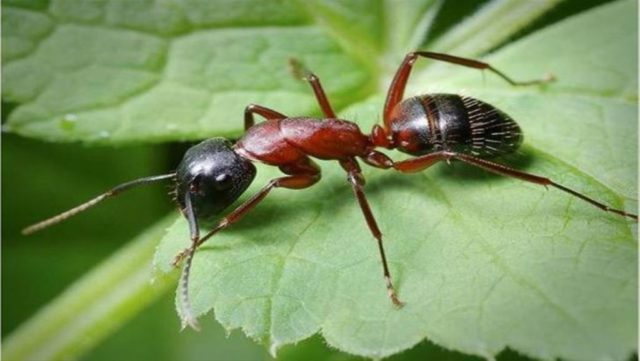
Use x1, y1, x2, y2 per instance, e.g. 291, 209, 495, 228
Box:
392, 151, 638, 222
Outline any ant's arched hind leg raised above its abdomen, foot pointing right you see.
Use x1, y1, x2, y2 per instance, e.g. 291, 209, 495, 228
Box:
383, 51, 554, 131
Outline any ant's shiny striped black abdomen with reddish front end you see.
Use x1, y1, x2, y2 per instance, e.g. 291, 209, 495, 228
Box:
391, 94, 522, 158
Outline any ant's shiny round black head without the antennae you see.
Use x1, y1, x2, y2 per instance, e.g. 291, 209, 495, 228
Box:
176, 138, 256, 221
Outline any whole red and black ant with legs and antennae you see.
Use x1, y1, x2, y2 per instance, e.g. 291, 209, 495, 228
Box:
23, 51, 638, 329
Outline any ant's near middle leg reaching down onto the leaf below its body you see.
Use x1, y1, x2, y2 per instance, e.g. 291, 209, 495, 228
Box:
340, 158, 402, 307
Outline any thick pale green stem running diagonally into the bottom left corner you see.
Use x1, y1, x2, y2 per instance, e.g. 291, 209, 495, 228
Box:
2, 215, 178, 361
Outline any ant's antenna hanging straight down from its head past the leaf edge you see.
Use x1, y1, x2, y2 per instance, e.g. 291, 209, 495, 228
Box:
180, 185, 200, 331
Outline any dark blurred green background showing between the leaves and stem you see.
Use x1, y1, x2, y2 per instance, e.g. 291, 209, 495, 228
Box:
2, 0, 628, 360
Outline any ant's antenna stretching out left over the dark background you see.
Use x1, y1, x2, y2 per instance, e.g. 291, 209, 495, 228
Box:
22, 173, 176, 235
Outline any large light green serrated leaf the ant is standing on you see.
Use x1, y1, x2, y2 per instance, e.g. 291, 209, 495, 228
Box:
152, 1, 637, 360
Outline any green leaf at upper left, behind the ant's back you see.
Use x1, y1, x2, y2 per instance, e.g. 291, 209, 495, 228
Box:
2, 0, 370, 143
